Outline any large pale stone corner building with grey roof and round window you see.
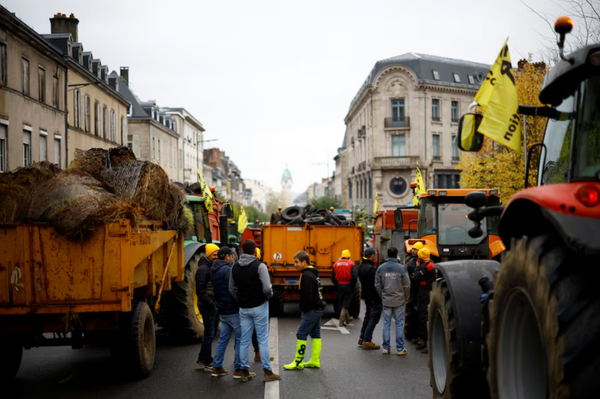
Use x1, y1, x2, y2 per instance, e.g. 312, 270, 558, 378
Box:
334, 53, 490, 207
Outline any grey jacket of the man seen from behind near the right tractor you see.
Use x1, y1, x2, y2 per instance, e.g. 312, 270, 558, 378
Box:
375, 258, 410, 308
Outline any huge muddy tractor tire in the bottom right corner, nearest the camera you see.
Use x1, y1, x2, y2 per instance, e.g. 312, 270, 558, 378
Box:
488, 235, 600, 399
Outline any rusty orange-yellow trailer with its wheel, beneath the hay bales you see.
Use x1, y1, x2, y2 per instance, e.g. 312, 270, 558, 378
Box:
0, 220, 185, 379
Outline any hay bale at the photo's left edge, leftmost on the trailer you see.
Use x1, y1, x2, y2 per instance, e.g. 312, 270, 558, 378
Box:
0, 161, 61, 223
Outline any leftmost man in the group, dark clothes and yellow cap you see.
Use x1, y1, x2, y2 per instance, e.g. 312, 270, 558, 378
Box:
195, 244, 219, 373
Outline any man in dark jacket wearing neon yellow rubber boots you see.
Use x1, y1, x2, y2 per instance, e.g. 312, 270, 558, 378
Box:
283, 251, 326, 370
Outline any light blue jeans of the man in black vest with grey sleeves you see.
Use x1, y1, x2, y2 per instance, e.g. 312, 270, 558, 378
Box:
240, 301, 271, 371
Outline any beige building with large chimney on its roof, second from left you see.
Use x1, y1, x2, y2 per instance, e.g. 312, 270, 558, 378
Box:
42, 14, 129, 165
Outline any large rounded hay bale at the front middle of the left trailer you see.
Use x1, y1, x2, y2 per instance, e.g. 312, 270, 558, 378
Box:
27, 170, 143, 239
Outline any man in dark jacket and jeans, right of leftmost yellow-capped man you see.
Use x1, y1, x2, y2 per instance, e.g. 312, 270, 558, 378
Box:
210, 247, 256, 378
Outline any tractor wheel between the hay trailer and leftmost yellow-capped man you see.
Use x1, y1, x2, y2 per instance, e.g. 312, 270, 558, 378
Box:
161, 254, 204, 340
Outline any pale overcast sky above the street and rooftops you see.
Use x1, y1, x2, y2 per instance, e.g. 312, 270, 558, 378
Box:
0, 0, 561, 192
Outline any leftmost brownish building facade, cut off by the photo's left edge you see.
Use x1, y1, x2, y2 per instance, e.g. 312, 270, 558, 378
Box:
0, 6, 67, 172
